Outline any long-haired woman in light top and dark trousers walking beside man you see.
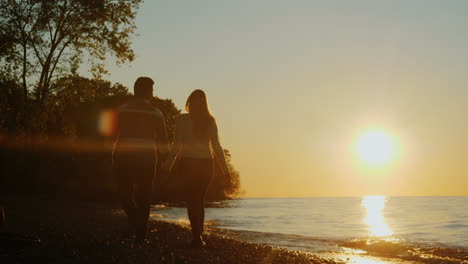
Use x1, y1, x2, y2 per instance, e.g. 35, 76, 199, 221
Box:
171, 90, 231, 248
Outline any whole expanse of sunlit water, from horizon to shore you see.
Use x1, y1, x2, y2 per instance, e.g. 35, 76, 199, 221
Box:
153, 196, 468, 263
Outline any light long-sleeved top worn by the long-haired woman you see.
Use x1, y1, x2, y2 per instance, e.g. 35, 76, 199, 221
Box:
172, 114, 229, 171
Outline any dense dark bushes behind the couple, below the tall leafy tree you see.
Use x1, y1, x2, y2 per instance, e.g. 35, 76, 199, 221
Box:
0, 76, 239, 202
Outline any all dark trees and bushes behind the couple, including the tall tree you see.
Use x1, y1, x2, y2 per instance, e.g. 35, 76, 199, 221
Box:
0, 0, 239, 201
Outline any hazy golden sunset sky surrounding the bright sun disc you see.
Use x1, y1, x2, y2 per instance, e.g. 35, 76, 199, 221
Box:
97, 0, 468, 197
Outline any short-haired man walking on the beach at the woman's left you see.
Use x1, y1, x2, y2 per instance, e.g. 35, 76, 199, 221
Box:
113, 77, 170, 243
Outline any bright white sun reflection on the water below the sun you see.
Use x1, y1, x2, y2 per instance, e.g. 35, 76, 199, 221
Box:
361, 196, 393, 237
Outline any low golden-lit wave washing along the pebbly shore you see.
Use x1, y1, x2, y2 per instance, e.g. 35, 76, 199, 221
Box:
207, 225, 468, 264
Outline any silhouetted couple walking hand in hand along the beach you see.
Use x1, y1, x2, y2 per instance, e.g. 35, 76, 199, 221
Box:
112, 77, 230, 248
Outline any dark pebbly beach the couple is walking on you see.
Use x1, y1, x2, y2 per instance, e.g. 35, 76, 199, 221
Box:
0, 195, 340, 264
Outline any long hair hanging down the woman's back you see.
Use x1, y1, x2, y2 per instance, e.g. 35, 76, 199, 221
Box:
185, 89, 215, 137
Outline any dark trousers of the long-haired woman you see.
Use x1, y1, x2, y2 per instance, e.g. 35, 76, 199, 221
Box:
179, 158, 213, 238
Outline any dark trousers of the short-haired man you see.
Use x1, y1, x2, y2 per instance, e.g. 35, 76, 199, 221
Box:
114, 166, 155, 240
